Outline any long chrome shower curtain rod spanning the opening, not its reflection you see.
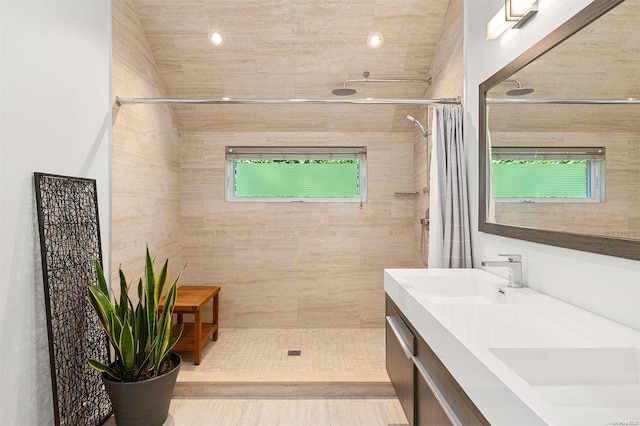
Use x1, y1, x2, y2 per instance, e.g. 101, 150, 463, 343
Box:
116, 96, 461, 106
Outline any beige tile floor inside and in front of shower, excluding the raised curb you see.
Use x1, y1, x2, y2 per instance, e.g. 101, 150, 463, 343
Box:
106, 329, 408, 426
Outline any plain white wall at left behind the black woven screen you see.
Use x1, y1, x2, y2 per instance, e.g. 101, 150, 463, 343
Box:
0, 0, 111, 425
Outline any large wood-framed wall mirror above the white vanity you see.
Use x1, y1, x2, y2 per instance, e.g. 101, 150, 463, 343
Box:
479, 0, 640, 260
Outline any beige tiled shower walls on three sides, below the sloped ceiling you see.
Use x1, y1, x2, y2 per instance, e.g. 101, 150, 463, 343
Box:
112, 0, 462, 328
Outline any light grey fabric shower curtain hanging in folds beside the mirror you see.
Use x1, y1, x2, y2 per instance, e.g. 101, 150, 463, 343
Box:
427, 105, 472, 268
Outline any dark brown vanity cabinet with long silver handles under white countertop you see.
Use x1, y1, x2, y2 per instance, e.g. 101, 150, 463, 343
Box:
386, 296, 489, 426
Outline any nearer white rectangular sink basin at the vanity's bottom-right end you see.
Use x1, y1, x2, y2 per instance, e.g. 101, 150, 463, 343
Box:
489, 347, 640, 425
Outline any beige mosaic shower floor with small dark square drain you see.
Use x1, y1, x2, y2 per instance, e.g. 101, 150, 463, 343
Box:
181, 328, 385, 372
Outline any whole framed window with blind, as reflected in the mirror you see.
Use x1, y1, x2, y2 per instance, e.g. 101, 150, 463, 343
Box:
491, 147, 605, 202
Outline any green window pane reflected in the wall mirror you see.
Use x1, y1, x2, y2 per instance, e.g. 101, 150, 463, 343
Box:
492, 161, 588, 198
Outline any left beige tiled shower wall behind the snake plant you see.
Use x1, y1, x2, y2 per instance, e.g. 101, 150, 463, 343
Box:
111, 0, 181, 287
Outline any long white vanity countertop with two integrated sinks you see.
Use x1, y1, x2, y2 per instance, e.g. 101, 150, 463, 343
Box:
384, 269, 640, 426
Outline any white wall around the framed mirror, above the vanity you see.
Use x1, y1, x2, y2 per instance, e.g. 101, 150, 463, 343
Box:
464, 0, 640, 330
